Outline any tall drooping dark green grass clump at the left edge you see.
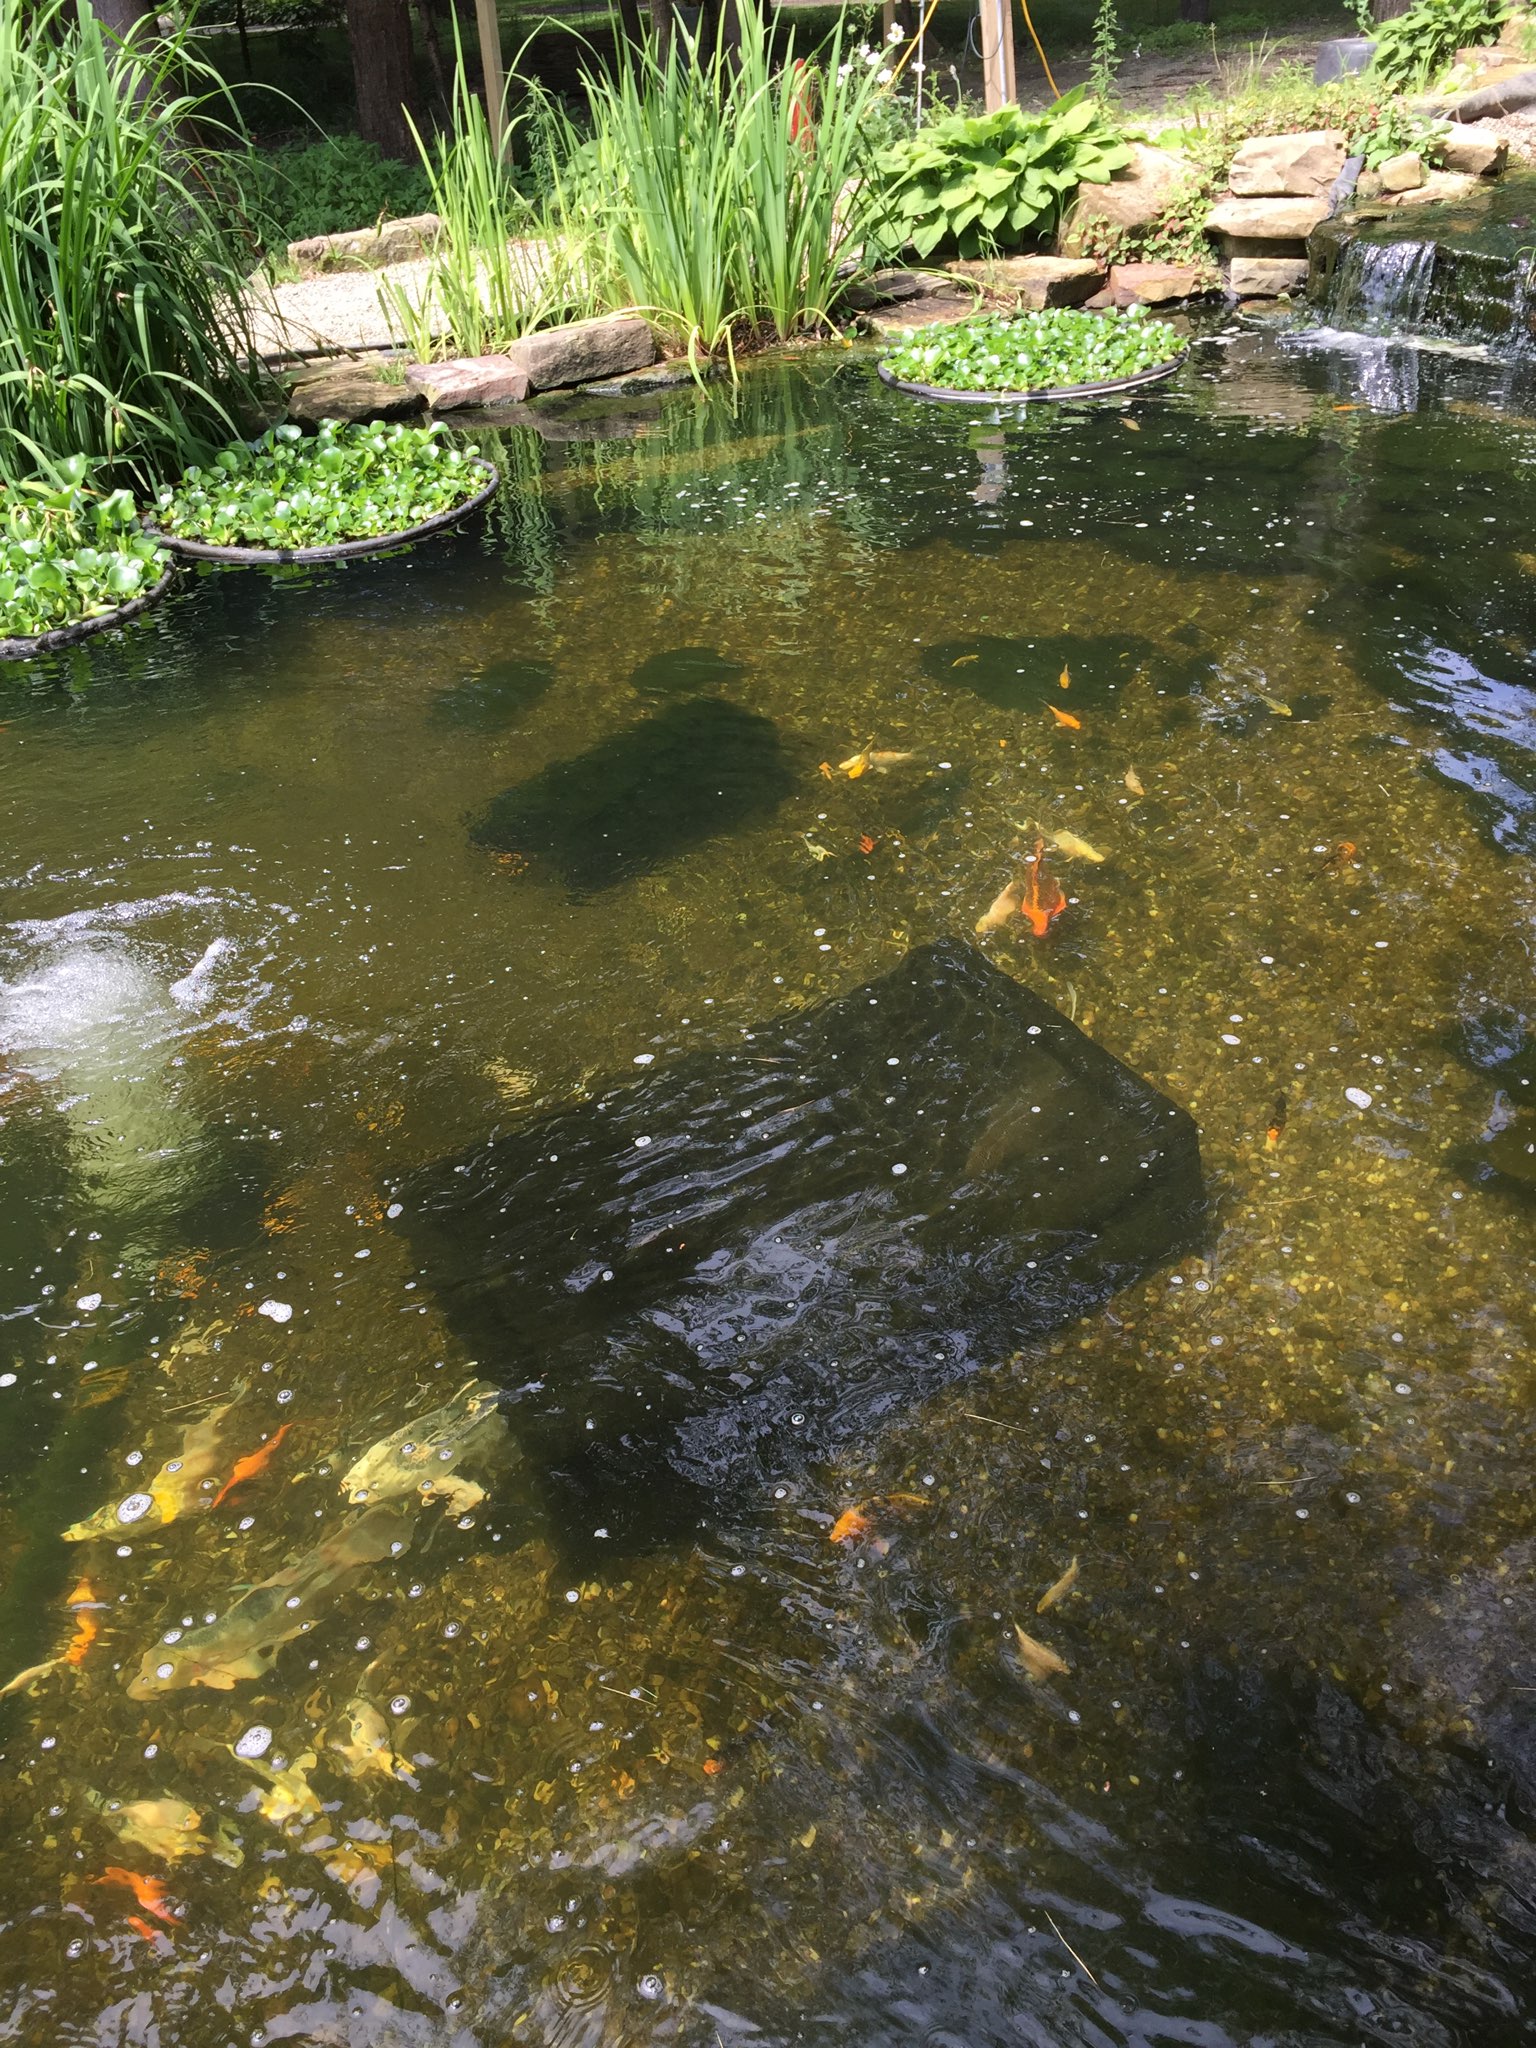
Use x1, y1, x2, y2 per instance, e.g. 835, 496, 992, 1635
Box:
0, 0, 254, 485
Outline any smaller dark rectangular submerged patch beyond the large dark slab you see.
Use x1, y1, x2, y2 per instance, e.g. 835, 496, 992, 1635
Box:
469, 696, 795, 895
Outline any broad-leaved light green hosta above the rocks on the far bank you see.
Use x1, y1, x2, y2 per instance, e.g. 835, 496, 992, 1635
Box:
877, 86, 1130, 256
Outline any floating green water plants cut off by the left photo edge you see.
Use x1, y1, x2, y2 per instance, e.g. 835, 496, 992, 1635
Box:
0, 457, 168, 639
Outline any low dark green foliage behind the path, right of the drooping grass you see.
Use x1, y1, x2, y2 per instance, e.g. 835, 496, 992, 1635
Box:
221, 135, 432, 250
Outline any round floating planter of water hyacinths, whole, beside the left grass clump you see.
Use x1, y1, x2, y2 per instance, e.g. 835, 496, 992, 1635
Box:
154, 420, 485, 549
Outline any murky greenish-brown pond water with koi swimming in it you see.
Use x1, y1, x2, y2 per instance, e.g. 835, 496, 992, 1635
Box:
0, 330, 1536, 2048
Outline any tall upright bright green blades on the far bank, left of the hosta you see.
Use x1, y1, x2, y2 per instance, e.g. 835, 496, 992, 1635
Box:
551, 0, 889, 354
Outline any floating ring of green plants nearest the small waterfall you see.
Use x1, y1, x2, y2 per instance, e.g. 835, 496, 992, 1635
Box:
885, 307, 1184, 391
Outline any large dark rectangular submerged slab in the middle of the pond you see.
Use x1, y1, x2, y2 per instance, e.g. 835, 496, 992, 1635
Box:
403, 942, 1204, 1518
